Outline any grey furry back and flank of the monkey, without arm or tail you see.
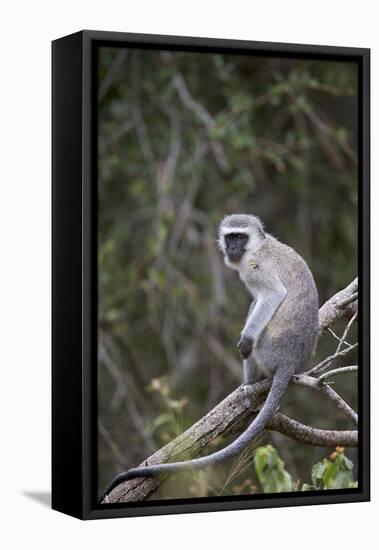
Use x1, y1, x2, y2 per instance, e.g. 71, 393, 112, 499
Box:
252, 235, 319, 372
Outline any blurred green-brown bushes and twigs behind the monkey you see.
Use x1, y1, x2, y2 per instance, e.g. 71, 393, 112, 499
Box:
98, 48, 357, 498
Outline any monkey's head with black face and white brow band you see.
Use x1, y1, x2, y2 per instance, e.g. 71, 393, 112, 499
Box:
218, 214, 266, 269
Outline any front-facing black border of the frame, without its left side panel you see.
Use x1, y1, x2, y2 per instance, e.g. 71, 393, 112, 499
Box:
52, 31, 370, 519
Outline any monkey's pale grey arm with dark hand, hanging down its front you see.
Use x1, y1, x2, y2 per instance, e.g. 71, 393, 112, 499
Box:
237, 278, 287, 359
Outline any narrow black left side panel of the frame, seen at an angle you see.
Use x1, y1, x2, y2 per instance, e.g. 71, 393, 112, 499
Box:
51, 33, 83, 517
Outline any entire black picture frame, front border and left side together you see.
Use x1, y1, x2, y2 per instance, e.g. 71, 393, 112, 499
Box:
52, 31, 370, 519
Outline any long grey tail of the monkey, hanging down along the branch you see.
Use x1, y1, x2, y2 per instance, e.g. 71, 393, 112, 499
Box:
100, 369, 292, 502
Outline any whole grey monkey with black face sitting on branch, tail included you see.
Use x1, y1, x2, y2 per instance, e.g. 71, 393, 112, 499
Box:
101, 214, 319, 500
